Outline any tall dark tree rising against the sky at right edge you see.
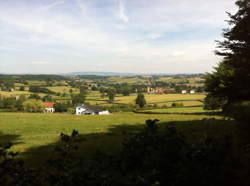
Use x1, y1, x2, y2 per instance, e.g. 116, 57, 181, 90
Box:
206, 0, 250, 114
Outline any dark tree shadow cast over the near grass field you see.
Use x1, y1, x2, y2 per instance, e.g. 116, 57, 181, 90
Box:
15, 119, 237, 166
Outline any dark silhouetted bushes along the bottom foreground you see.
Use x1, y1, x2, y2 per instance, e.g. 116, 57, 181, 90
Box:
0, 120, 249, 186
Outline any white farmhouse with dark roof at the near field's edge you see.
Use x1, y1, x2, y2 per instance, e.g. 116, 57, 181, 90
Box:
76, 104, 109, 115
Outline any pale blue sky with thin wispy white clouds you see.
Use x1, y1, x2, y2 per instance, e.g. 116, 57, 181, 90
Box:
0, 0, 237, 74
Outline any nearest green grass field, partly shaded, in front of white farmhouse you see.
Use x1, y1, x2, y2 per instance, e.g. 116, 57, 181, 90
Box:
0, 113, 221, 163
